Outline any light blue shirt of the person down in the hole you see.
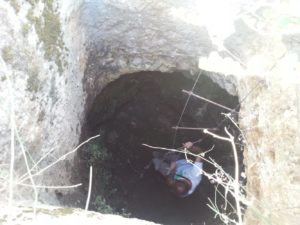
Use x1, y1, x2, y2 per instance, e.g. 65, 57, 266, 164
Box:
174, 159, 203, 197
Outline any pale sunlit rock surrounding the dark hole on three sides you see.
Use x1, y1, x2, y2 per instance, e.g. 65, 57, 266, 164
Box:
0, 0, 300, 224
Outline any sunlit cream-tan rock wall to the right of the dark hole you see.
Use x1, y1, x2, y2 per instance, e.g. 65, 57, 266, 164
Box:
240, 71, 300, 224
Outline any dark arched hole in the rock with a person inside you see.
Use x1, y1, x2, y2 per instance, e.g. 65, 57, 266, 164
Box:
80, 72, 238, 224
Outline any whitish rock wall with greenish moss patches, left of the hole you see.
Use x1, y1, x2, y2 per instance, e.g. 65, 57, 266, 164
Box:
0, 1, 85, 204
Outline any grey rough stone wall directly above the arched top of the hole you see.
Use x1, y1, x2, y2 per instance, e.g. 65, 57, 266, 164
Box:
81, 0, 213, 106
